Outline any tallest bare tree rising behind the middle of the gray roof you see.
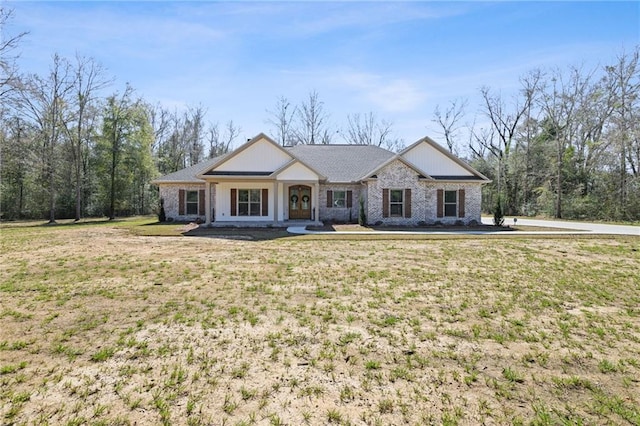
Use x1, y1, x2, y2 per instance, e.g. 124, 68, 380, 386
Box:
294, 90, 331, 145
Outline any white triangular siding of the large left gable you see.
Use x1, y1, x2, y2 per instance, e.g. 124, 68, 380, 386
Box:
213, 139, 291, 172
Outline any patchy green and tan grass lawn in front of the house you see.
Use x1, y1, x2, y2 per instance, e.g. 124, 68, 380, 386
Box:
0, 218, 640, 425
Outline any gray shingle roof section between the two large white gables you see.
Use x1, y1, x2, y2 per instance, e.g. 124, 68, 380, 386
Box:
286, 145, 394, 182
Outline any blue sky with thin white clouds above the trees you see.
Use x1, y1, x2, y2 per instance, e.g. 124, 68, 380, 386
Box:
5, 0, 640, 150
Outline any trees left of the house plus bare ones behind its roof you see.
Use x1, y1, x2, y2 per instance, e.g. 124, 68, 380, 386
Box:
0, 7, 399, 222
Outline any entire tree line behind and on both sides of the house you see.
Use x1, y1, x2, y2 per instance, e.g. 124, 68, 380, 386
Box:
0, 8, 640, 222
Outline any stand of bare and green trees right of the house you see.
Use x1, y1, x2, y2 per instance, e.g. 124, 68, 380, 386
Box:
442, 47, 640, 221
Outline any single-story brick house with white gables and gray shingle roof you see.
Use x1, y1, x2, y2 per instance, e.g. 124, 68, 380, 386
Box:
152, 133, 489, 226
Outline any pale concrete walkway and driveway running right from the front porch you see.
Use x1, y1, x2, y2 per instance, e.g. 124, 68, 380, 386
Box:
287, 217, 640, 236
